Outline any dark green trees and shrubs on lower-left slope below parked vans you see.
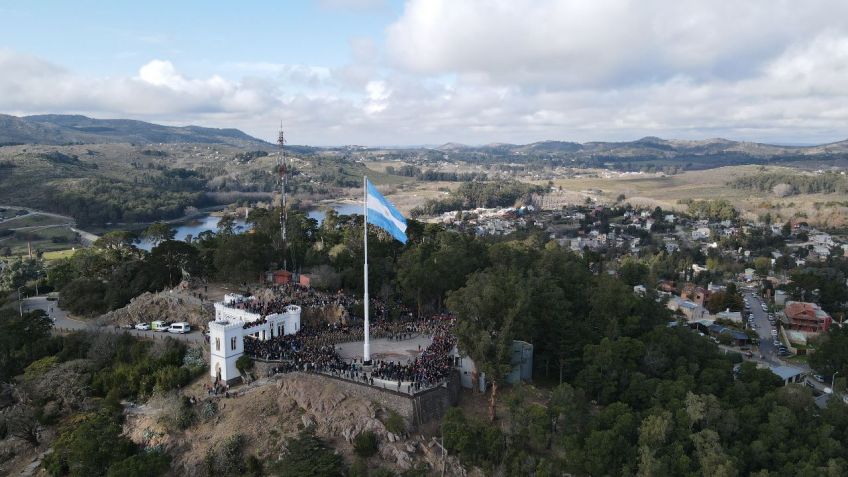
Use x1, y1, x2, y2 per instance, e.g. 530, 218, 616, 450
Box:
0, 308, 206, 477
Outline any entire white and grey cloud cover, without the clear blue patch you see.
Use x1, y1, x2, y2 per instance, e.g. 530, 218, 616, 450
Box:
0, 0, 848, 145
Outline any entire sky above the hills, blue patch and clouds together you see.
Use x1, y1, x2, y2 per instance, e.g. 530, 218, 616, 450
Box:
0, 0, 848, 145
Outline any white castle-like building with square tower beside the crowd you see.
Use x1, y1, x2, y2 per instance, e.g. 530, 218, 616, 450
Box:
209, 293, 300, 382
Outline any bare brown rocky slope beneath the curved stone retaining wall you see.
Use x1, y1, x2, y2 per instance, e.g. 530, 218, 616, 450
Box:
125, 373, 466, 476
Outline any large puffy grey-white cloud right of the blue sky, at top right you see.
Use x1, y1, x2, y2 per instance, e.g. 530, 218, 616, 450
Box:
387, 0, 848, 88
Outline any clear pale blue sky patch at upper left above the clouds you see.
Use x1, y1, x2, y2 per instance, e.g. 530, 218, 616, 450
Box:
0, 0, 399, 76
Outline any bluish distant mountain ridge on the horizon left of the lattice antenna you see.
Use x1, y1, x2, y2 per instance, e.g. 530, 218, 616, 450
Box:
0, 114, 273, 149
